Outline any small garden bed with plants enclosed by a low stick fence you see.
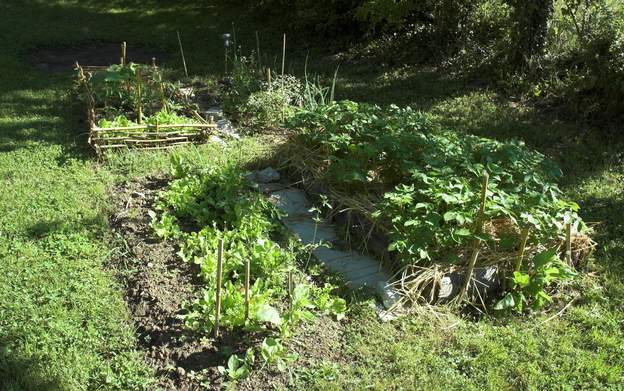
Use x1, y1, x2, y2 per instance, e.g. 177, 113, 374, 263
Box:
76, 48, 217, 156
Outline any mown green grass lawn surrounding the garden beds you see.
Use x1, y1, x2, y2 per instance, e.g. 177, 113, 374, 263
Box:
0, 0, 624, 390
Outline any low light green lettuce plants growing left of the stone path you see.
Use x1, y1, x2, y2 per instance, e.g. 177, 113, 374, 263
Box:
150, 155, 345, 380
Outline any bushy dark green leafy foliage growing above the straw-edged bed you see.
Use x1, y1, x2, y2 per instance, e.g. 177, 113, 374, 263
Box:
289, 101, 586, 310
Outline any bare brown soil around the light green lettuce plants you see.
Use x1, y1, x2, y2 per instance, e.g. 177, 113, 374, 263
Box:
110, 177, 344, 391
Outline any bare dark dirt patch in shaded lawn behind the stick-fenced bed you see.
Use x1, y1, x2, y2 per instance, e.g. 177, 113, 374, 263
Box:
27, 43, 169, 71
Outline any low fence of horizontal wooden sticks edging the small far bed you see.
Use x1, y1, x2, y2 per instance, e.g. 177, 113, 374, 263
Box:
76, 54, 217, 156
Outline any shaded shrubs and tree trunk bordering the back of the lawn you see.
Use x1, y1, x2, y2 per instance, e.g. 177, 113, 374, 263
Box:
246, 0, 624, 120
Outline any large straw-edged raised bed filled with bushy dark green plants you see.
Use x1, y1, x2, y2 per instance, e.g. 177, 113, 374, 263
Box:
280, 101, 594, 311
